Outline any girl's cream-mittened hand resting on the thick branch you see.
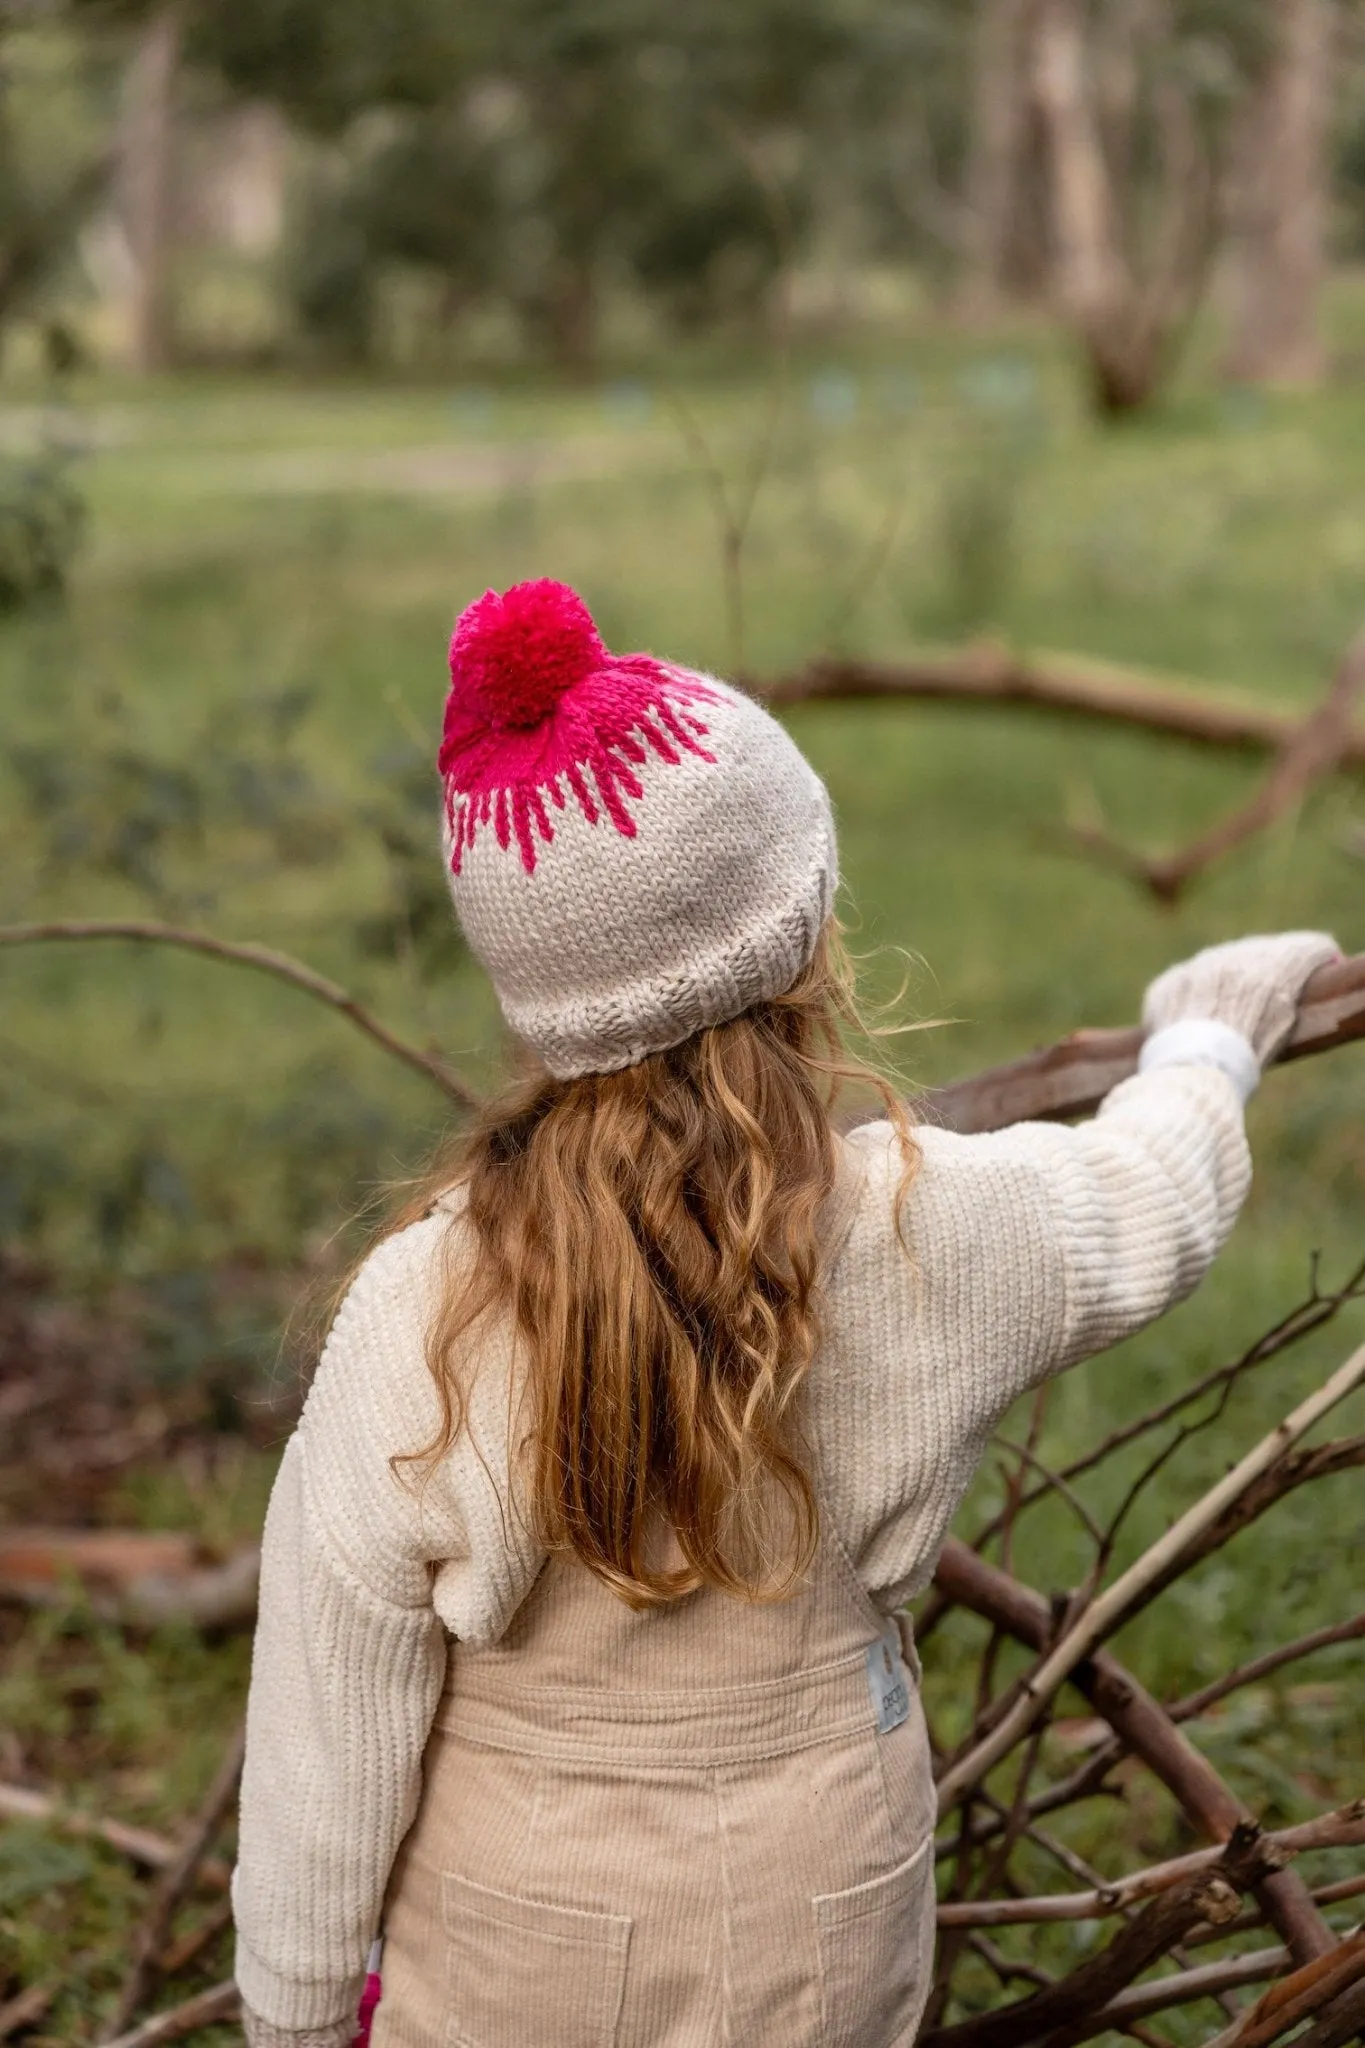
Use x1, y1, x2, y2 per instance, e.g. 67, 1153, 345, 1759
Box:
1142, 932, 1340, 1067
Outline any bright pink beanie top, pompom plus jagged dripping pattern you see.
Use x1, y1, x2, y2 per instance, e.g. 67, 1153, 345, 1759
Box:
440, 578, 716, 874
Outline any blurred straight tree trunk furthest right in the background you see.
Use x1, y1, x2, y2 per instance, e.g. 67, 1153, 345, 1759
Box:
1228, 0, 1334, 385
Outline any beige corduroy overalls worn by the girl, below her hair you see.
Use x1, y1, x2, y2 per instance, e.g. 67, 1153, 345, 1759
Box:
375, 1518, 933, 2048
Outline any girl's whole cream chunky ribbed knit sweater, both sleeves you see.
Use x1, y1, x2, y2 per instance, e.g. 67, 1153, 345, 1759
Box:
233, 1065, 1250, 2048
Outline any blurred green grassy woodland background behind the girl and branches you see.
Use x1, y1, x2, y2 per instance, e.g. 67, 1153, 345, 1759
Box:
0, 0, 1365, 2044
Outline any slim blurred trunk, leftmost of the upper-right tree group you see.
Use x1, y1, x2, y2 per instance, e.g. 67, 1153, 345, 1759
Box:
962, 0, 1033, 319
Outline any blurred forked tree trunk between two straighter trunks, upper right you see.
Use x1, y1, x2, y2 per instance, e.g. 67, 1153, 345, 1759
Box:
1033, 0, 1216, 416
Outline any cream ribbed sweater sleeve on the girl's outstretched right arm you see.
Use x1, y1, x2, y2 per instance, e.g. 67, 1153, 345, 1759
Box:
810, 1065, 1250, 1610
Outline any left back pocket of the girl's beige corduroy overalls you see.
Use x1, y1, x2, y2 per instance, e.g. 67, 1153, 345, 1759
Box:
442, 1872, 630, 2048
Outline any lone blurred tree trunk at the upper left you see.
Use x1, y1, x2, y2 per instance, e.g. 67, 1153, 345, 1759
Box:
119, 4, 182, 373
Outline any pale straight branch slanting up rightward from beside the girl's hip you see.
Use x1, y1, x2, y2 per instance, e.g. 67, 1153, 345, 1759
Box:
939, 1346, 1365, 1812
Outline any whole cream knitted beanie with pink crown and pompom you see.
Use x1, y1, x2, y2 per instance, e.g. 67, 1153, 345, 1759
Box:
440, 580, 837, 1079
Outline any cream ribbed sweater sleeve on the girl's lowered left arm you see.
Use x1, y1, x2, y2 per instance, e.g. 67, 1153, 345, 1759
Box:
233, 1212, 538, 2040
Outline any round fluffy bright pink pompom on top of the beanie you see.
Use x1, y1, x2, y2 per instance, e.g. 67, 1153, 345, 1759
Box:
450, 575, 608, 731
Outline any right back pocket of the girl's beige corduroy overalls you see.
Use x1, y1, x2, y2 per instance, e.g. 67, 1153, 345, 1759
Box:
810, 1835, 935, 2048
